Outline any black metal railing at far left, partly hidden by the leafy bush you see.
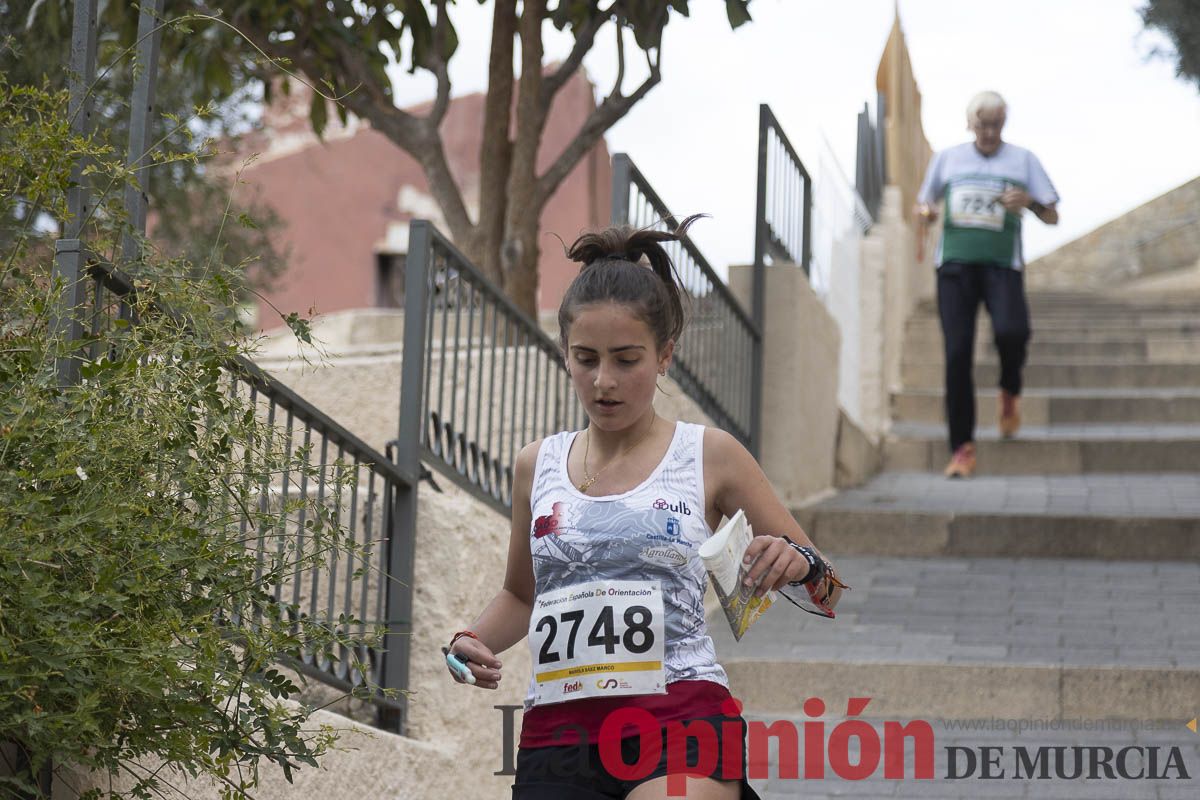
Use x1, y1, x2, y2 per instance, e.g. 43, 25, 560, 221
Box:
52, 255, 418, 730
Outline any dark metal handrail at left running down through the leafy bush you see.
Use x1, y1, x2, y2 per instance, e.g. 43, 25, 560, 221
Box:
58, 247, 419, 730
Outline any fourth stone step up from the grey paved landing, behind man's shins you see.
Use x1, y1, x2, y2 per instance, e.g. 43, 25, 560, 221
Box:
901, 356, 1200, 389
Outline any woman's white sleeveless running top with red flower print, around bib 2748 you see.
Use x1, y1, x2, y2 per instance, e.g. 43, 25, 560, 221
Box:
526, 422, 728, 708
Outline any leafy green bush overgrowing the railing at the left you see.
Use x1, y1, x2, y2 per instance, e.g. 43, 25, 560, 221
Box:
0, 77, 381, 798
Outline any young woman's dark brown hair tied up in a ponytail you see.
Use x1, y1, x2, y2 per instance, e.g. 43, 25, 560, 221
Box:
558, 213, 704, 353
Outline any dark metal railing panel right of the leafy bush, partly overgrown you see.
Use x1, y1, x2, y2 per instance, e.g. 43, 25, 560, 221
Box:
230, 357, 416, 730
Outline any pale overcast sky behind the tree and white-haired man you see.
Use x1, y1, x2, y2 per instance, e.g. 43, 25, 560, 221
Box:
386, 0, 1200, 267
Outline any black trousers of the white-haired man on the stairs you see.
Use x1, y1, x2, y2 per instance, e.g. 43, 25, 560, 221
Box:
937, 261, 1030, 451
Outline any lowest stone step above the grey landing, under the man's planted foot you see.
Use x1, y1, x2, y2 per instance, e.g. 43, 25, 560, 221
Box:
793, 473, 1200, 561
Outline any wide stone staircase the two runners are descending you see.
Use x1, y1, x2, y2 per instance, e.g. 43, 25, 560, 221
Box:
712, 293, 1200, 799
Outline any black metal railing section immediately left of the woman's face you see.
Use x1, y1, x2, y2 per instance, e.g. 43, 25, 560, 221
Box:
400, 219, 587, 513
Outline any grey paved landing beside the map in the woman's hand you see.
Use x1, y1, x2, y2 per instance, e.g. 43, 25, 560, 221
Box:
709, 557, 1200, 671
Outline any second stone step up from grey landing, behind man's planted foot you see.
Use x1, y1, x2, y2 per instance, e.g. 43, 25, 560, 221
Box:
883, 422, 1200, 475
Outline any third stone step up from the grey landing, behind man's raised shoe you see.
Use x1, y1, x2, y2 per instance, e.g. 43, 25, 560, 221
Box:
892, 389, 1200, 426
